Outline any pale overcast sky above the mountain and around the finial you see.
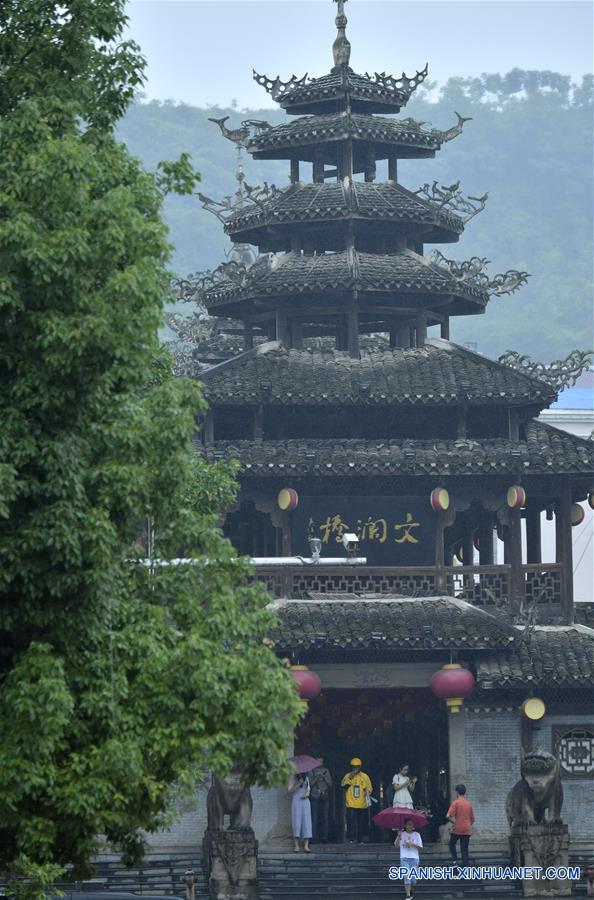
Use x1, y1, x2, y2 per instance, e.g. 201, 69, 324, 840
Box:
128, 0, 594, 108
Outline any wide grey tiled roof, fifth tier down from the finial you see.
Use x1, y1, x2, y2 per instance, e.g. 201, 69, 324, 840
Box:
201, 339, 555, 406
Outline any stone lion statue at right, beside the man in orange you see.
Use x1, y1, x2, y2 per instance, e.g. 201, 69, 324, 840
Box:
505, 750, 563, 827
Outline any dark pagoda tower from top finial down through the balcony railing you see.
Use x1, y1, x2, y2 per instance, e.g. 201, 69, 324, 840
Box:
191, 0, 594, 621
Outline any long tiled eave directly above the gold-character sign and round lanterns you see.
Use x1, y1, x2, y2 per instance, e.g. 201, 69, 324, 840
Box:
200, 421, 594, 477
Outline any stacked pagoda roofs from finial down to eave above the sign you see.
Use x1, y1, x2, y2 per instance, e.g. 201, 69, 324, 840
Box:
191, 0, 594, 548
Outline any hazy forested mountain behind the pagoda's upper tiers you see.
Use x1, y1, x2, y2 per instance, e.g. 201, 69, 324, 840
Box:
119, 69, 593, 361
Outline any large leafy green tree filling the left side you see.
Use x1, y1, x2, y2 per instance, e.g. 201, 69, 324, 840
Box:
0, 0, 298, 895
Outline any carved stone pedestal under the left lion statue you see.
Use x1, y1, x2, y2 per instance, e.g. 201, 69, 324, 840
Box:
202, 828, 258, 900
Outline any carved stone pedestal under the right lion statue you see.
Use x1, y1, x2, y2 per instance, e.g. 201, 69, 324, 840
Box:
510, 822, 571, 897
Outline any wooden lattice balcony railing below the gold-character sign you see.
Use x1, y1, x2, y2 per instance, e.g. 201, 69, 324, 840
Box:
255, 563, 563, 610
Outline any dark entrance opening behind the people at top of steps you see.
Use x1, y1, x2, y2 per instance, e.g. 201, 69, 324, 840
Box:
295, 688, 449, 843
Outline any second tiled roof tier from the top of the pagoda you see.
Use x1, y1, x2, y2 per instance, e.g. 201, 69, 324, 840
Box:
248, 113, 443, 157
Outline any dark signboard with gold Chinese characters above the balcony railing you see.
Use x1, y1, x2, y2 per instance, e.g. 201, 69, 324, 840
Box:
292, 495, 435, 566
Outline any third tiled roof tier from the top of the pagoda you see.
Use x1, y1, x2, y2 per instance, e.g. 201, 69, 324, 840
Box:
225, 180, 464, 241
